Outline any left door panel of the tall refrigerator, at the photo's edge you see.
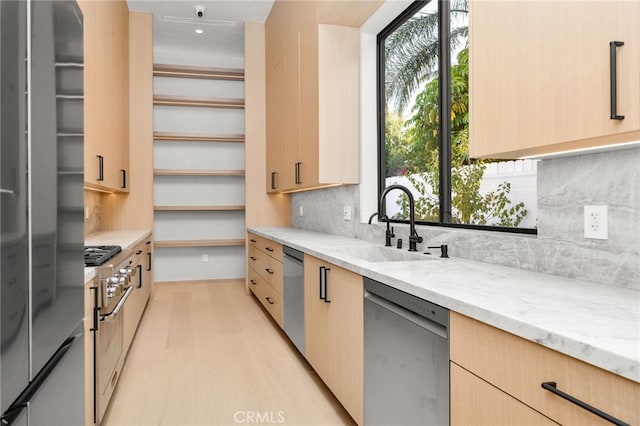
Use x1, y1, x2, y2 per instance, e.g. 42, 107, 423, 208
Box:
0, 0, 29, 418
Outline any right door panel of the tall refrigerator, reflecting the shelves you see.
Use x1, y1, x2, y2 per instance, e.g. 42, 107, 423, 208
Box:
30, 1, 84, 380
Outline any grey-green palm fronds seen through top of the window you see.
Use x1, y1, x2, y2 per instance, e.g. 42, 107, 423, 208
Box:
385, 0, 468, 112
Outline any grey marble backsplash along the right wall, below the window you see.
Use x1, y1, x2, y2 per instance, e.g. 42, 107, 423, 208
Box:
291, 148, 640, 290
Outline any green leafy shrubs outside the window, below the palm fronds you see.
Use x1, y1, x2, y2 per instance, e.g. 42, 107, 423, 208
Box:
387, 48, 527, 227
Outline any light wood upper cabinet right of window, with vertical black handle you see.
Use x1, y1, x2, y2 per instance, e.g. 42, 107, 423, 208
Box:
469, 0, 640, 158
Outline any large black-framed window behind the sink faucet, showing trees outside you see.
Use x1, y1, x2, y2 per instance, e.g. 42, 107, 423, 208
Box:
378, 0, 536, 233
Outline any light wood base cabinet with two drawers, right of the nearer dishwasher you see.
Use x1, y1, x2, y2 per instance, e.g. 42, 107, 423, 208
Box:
450, 311, 640, 426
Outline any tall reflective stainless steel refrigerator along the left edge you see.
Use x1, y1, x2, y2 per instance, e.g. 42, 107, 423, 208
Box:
0, 0, 85, 426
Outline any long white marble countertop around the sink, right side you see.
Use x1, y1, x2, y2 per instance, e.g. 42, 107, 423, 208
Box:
249, 228, 640, 383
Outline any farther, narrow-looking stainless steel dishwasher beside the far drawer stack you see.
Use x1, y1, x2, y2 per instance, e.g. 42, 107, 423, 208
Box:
282, 246, 304, 354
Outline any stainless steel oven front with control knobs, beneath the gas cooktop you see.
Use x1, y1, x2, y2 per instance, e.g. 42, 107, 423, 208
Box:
93, 250, 136, 424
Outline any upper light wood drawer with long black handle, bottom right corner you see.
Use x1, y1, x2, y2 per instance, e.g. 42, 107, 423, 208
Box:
450, 311, 640, 425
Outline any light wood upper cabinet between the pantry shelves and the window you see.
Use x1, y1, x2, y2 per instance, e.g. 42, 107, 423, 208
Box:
265, 0, 381, 192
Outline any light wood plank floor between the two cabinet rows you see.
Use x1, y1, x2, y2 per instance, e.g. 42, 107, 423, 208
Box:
102, 281, 353, 426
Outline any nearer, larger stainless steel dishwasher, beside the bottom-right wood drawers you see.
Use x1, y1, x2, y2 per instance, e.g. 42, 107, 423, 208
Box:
364, 277, 449, 425
